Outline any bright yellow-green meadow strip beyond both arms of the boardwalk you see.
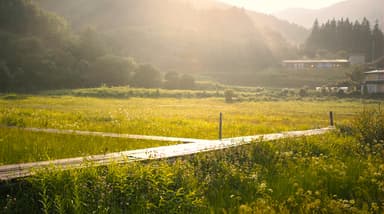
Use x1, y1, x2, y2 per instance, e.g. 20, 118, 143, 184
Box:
0, 96, 372, 139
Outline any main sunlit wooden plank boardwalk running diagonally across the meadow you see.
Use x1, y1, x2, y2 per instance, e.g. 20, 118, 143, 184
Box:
0, 127, 334, 181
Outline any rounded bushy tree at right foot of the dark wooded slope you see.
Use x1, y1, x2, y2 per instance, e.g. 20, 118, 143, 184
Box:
132, 64, 161, 88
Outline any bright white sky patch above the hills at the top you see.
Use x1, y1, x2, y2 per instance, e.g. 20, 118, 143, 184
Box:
219, 0, 343, 13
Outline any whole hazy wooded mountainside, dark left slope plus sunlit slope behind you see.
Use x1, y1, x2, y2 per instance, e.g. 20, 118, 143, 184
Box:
0, 0, 306, 91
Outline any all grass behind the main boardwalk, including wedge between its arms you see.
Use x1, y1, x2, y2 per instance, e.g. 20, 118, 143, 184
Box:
0, 93, 377, 164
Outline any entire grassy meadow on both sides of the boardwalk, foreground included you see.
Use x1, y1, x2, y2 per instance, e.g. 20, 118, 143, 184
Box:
0, 91, 384, 213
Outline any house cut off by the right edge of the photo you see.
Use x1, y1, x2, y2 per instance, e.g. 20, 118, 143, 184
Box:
361, 70, 384, 94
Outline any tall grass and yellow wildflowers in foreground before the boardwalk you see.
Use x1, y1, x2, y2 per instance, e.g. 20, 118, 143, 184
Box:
0, 133, 384, 213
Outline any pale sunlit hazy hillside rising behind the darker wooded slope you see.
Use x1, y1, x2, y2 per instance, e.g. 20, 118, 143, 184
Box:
35, 0, 300, 73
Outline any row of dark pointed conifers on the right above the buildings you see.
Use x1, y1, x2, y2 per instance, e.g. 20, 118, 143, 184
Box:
305, 18, 384, 61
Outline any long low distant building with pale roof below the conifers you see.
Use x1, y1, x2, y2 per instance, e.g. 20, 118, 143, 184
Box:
282, 59, 350, 70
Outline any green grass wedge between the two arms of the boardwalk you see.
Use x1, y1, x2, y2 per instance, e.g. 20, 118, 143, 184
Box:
0, 127, 175, 165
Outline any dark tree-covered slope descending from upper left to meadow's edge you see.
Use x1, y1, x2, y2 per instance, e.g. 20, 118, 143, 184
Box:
0, 0, 194, 92
